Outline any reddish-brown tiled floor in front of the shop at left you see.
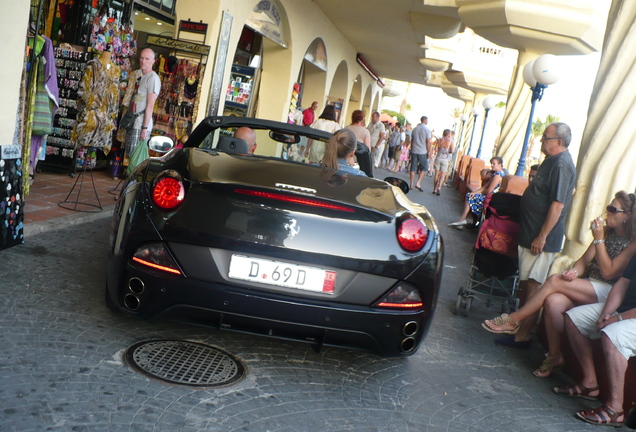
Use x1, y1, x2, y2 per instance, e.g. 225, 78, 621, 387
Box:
24, 170, 121, 224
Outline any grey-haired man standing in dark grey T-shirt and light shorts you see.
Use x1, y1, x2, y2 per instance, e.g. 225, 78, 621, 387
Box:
495, 123, 576, 348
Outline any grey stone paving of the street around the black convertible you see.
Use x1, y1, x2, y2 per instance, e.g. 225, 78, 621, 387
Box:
0, 171, 612, 432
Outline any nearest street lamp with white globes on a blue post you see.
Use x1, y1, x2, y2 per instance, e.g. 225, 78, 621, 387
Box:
515, 54, 559, 176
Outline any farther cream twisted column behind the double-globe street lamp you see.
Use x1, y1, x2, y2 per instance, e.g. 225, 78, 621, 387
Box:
495, 51, 540, 173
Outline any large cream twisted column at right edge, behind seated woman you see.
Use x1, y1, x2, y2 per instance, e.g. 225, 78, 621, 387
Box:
553, 0, 636, 271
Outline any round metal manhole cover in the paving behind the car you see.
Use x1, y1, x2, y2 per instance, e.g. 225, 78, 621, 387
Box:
124, 340, 245, 388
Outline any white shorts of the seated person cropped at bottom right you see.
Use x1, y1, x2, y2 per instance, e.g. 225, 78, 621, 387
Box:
566, 303, 636, 359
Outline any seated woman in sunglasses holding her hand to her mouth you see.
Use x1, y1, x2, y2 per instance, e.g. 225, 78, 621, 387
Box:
482, 191, 636, 378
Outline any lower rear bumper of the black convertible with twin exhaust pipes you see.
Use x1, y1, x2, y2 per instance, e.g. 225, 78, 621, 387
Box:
108, 265, 433, 356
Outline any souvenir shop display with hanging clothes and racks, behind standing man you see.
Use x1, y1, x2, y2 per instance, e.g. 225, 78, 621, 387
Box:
25, 0, 209, 177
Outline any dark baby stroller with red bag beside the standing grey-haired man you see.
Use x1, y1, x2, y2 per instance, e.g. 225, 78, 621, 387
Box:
453, 192, 521, 316
